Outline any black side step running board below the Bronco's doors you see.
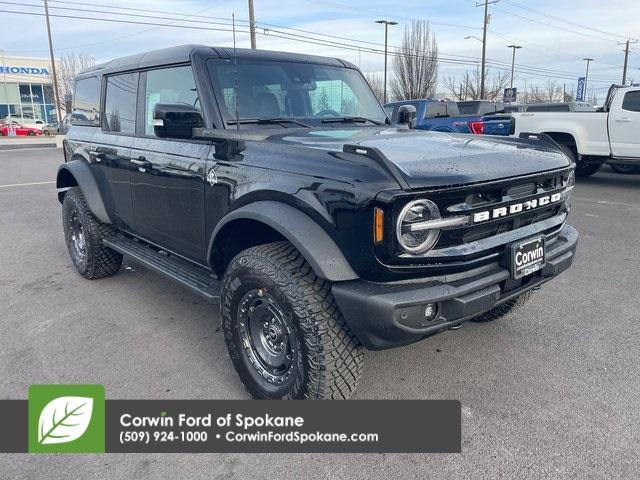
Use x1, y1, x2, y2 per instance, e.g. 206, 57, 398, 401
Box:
103, 235, 222, 304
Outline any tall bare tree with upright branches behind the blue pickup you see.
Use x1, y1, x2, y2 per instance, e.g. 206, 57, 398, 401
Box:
391, 20, 438, 100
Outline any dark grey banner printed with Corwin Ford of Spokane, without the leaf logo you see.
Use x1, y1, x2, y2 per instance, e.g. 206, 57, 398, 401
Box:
0, 400, 461, 453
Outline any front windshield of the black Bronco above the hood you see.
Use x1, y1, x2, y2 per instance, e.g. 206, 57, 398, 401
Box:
209, 60, 387, 128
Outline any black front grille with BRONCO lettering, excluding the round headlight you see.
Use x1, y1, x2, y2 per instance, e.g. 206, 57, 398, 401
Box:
377, 168, 571, 271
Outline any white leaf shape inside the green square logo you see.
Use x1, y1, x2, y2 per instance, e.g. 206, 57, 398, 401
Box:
38, 397, 93, 445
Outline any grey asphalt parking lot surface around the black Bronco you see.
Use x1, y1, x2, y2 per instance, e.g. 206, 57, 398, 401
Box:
0, 148, 640, 480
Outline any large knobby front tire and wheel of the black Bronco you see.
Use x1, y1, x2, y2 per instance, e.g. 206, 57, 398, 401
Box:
220, 241, 364, 399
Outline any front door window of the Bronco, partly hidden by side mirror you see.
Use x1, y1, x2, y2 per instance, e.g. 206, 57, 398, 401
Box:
144, 66, 200, 136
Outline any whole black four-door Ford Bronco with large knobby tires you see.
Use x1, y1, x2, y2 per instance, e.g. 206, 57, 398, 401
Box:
57, 45, 578, 399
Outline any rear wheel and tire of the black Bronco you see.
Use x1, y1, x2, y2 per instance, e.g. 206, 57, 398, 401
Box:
62, 187, 122, 280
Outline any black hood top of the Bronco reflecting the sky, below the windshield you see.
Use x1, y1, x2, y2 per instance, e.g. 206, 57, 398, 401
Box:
280, 127, 569, 188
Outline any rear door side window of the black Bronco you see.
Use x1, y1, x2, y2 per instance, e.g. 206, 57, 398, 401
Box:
103, 73, 138, 134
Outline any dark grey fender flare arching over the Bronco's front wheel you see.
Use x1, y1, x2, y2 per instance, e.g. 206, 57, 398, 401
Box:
207, 200, 359, 282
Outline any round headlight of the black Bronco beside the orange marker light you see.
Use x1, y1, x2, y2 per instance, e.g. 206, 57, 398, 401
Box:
396, 200, 440, 255
